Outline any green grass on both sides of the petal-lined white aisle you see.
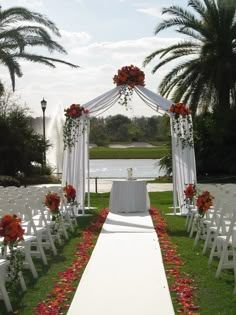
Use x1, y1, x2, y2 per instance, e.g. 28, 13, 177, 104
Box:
0, 192, 236, 315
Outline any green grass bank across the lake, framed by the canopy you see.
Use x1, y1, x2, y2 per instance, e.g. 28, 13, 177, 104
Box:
89, 145, 168, 159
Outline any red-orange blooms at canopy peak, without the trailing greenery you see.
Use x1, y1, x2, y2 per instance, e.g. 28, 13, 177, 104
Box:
113, 65, 145, 88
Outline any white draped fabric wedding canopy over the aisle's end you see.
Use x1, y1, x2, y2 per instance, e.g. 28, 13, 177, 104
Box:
62, 85, 196, 214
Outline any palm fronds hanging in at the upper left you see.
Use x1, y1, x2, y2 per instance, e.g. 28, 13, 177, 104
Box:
0, 6, 78, 95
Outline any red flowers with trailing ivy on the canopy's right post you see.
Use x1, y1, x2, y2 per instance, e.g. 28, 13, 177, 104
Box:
169, 103, 193, 148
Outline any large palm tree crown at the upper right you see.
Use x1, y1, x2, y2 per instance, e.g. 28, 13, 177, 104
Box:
144, 0, 236, 117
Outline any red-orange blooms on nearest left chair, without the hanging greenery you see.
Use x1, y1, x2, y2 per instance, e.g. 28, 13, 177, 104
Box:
0, 214, 25, 245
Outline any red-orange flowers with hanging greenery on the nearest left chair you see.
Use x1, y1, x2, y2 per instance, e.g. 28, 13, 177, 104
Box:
0, 214, 25, 291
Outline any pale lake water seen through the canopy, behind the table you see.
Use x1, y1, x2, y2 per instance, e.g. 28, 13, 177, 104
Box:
90, 159, 165, 178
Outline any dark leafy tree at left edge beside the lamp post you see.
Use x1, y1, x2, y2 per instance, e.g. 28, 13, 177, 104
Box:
0, 107, 48, 176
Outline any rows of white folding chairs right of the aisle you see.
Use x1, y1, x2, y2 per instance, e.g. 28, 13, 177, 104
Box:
186, 184, 236, 294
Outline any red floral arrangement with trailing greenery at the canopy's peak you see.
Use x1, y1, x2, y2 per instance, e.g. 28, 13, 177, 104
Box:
113, 65, 145, 107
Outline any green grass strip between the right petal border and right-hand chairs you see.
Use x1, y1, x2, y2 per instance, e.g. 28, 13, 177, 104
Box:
150, 192, 236, 315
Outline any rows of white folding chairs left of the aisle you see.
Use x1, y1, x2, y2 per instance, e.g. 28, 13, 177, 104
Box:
0, 186, 77, 312
